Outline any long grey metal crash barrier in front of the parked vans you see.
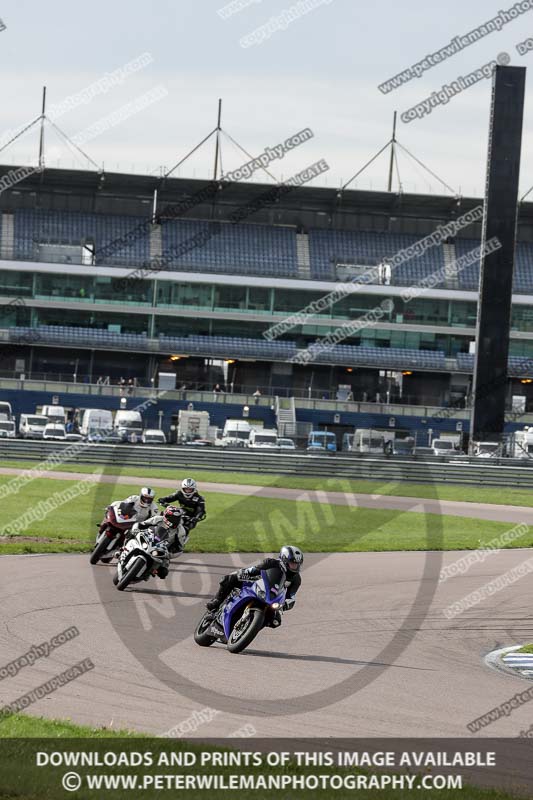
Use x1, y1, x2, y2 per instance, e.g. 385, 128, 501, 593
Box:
0, 439, 533, 489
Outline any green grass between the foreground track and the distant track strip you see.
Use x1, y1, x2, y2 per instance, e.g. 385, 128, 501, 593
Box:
0, 476, 532, 554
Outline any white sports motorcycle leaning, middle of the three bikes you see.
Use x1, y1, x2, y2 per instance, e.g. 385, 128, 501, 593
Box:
113, 528, 170, 592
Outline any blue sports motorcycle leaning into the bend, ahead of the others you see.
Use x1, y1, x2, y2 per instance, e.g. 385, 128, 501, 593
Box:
194, 567, 286, 653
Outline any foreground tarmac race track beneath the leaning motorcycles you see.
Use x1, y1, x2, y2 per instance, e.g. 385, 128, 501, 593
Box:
0, 550, 533, 738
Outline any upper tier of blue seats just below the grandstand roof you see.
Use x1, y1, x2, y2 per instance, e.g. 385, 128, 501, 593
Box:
14, 208, 533, 293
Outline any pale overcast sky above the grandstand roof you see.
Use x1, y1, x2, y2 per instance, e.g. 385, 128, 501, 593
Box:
0, 0, 533, 199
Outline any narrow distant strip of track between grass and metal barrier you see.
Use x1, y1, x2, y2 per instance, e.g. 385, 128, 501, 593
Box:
0, 467, 533, 523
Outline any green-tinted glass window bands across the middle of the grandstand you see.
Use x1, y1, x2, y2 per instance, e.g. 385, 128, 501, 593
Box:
0, 270, 533, 356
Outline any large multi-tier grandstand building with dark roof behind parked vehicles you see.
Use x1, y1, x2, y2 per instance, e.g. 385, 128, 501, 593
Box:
0, 168, 533, 444
